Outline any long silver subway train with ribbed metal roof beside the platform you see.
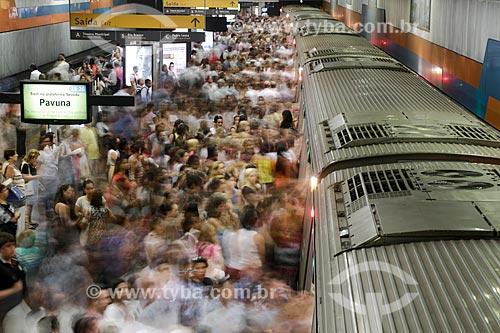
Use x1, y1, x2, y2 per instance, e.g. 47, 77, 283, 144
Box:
282, 6, 500, 333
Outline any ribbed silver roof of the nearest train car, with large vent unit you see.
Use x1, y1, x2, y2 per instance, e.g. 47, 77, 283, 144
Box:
314, 161, 500, 332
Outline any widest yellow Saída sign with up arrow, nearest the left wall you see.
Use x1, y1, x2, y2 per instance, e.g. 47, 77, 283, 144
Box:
70, 13, 205, 29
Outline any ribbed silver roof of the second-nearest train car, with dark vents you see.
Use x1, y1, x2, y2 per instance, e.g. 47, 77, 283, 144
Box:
303, 63, 500, 177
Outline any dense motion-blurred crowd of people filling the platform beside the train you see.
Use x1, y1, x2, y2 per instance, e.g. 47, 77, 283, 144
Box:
0, 12, 314, 333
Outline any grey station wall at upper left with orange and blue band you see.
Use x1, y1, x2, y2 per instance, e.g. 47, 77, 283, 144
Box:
0, 0, 125, 79
